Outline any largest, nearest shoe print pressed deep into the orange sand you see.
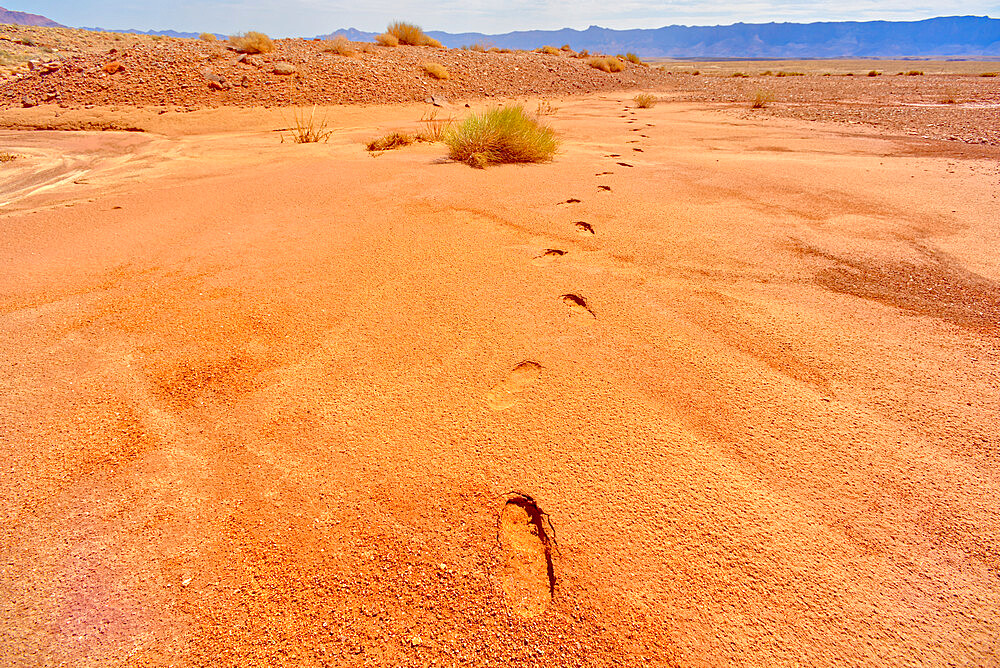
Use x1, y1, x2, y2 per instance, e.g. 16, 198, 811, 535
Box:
497, 494, 556, 617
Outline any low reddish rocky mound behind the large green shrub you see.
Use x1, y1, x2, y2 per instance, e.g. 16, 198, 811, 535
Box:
0, 33, 667, 107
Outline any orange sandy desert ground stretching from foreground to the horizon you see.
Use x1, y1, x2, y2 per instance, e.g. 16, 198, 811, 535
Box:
0, 28, 1000, 667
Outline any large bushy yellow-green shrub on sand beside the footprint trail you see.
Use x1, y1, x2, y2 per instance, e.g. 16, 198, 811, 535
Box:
444, 105, 559, 168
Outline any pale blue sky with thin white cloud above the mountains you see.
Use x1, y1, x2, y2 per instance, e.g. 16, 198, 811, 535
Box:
17, 0, 1000, 37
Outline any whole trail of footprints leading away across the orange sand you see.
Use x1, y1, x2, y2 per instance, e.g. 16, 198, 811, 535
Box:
486, 95, 653, 618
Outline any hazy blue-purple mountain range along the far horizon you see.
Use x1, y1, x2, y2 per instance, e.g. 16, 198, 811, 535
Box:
0, 8, 1000, 59
